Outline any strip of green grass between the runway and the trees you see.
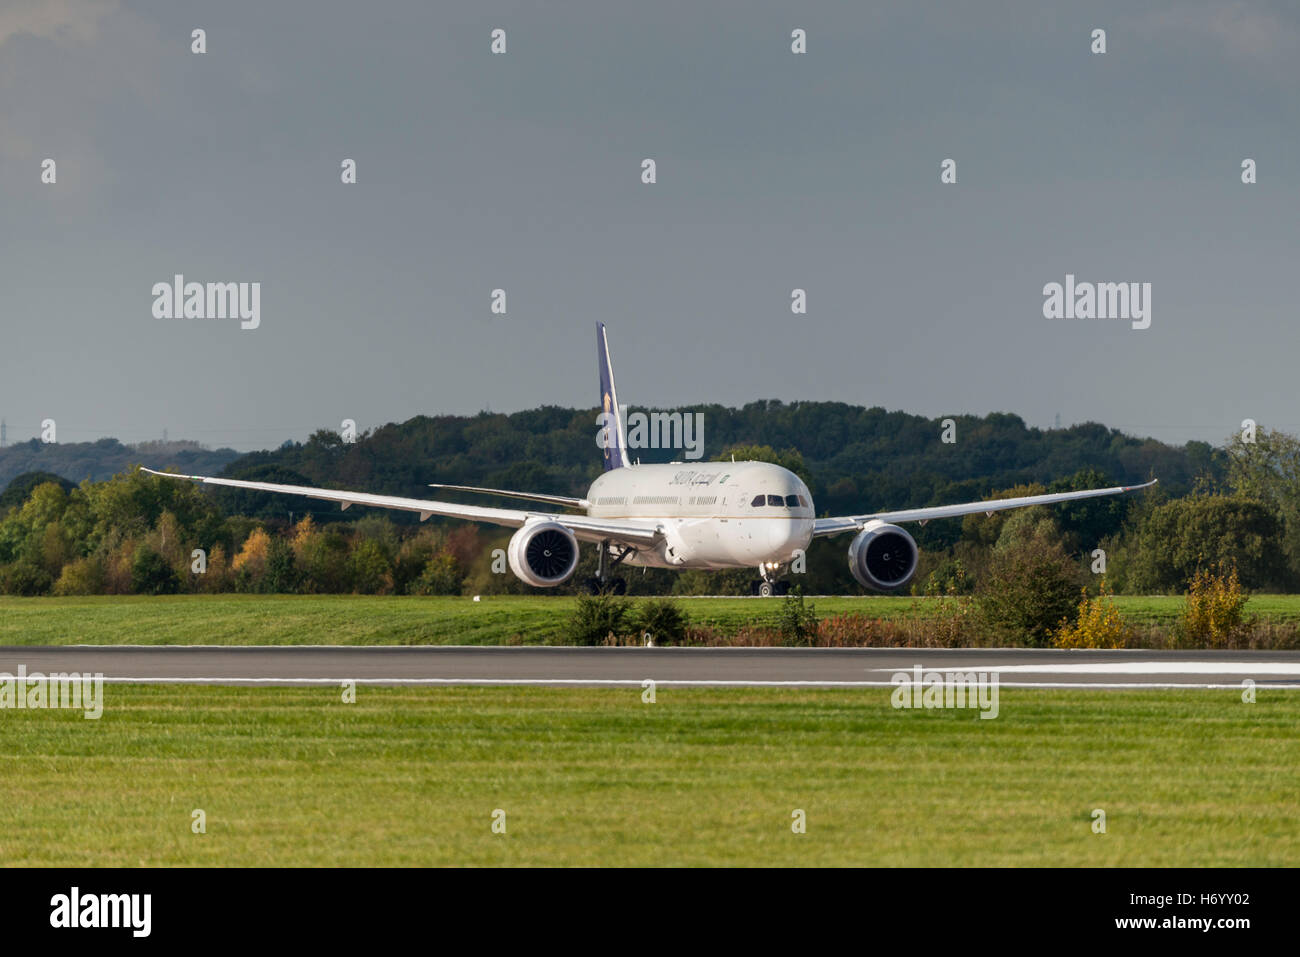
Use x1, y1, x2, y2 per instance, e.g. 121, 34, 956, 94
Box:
0, 594, 1300, 645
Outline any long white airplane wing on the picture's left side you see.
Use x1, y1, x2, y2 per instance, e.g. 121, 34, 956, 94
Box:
140, 465, 662, 547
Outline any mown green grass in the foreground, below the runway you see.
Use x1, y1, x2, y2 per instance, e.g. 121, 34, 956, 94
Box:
0, 685, 1300, 866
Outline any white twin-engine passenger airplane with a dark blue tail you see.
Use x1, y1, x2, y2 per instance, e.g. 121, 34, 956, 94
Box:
144, 322, 1156, 597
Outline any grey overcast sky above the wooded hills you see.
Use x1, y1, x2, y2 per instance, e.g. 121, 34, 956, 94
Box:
0, 0, 1300, 449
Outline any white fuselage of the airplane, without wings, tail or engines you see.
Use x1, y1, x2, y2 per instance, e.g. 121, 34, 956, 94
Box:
586, 462, 814, 568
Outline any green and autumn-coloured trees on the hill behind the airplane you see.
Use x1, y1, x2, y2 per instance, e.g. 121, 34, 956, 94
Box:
0, 402, 1300, 596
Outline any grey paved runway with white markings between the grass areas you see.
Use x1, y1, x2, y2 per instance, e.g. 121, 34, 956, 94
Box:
0, 645, 1300, 690
